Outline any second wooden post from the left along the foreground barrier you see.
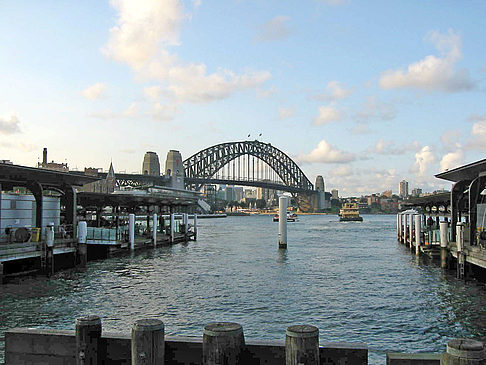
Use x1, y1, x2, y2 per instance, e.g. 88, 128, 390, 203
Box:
132, 319, 165, 365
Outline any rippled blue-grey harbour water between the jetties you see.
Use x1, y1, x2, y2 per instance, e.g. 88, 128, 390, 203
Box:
0, 215, 486, 364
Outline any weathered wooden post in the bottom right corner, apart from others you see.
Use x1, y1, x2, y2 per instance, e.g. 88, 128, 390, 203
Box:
440, 338, 486, 365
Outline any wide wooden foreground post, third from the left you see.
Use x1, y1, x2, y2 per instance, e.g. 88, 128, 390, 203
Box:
203, 322, 245, 365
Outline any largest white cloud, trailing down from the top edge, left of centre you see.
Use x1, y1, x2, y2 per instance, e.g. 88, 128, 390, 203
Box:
102, 0, 271, 103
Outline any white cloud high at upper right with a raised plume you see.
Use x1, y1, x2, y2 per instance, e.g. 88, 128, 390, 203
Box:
379, 30, 474, 92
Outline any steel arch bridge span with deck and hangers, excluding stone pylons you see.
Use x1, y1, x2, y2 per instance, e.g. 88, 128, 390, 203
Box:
183, 140, 315, 195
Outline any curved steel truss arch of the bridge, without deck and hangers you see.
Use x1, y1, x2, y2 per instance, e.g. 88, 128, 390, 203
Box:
183, 140, 314, 193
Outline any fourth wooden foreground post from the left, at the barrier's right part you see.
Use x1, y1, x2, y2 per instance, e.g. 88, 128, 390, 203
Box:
285, 325, 319, 365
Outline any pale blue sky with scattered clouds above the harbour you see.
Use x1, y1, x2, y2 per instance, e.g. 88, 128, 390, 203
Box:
0, 0, 486, 196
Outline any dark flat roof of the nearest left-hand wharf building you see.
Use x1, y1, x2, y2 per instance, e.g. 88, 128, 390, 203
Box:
0, 163, 99, 187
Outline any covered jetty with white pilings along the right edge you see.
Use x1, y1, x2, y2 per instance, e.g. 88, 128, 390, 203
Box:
397, 159, 486, 279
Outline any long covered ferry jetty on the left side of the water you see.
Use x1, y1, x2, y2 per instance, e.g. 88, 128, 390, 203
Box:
0, 163, 200, 283
